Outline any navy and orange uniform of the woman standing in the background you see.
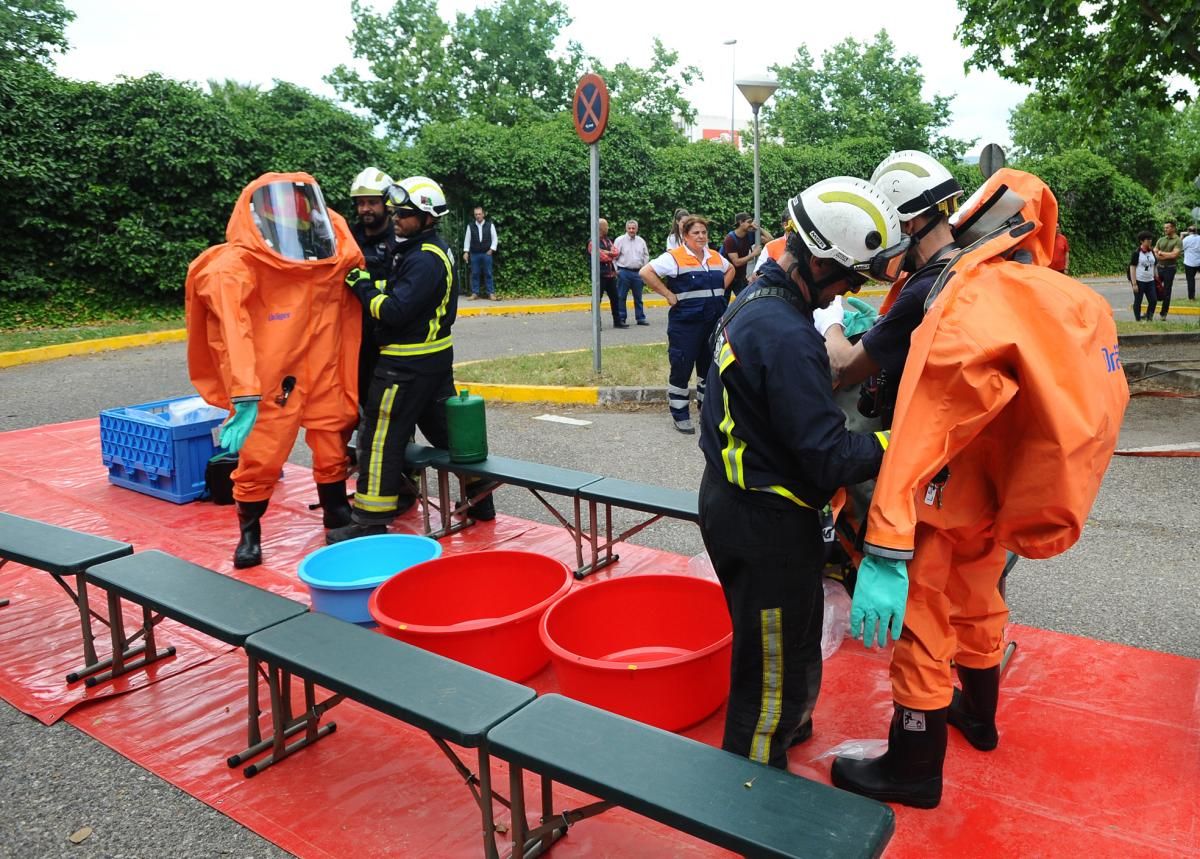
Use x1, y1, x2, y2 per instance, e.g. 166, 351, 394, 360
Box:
662, 246, 728, 421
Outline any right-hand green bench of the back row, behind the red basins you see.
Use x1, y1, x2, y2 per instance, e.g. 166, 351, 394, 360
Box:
575, 477, 700, 578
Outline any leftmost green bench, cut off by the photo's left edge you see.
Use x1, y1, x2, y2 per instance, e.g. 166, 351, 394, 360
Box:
0, 513, 134, 683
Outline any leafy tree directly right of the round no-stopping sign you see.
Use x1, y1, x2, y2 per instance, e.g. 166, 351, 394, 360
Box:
593, 37, 701, 146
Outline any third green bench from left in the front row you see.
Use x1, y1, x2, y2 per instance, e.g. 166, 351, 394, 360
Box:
243, 613, 535, 858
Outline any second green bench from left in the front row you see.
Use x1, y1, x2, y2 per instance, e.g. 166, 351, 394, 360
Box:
84, 549, 308, 753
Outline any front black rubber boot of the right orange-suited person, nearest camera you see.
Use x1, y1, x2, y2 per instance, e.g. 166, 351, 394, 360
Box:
830, 704, 949, 809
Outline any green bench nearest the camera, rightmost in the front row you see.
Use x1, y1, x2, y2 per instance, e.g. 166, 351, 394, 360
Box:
487, 695, 895, 859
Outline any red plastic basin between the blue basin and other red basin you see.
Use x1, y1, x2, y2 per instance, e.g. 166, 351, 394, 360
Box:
368, 552, 572, 681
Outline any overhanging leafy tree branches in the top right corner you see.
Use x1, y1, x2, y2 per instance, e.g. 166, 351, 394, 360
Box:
956, 0, 1200, 114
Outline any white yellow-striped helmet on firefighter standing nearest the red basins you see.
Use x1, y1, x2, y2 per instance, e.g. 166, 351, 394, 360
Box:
787, 176, 908, 282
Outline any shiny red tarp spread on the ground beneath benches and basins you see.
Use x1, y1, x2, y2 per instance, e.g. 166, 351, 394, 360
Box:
0, 420, 1200, 859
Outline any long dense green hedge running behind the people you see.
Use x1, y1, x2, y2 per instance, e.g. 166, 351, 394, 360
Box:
0, 62, 1158, 328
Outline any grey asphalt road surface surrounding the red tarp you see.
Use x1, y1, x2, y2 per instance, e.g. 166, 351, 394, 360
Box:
0, 297, 1200, 859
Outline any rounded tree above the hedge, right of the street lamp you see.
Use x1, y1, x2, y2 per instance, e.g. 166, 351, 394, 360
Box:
763, 30, 973, 158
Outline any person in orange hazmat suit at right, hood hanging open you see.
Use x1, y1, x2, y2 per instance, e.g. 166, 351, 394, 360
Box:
832, 168, 1129, 809
